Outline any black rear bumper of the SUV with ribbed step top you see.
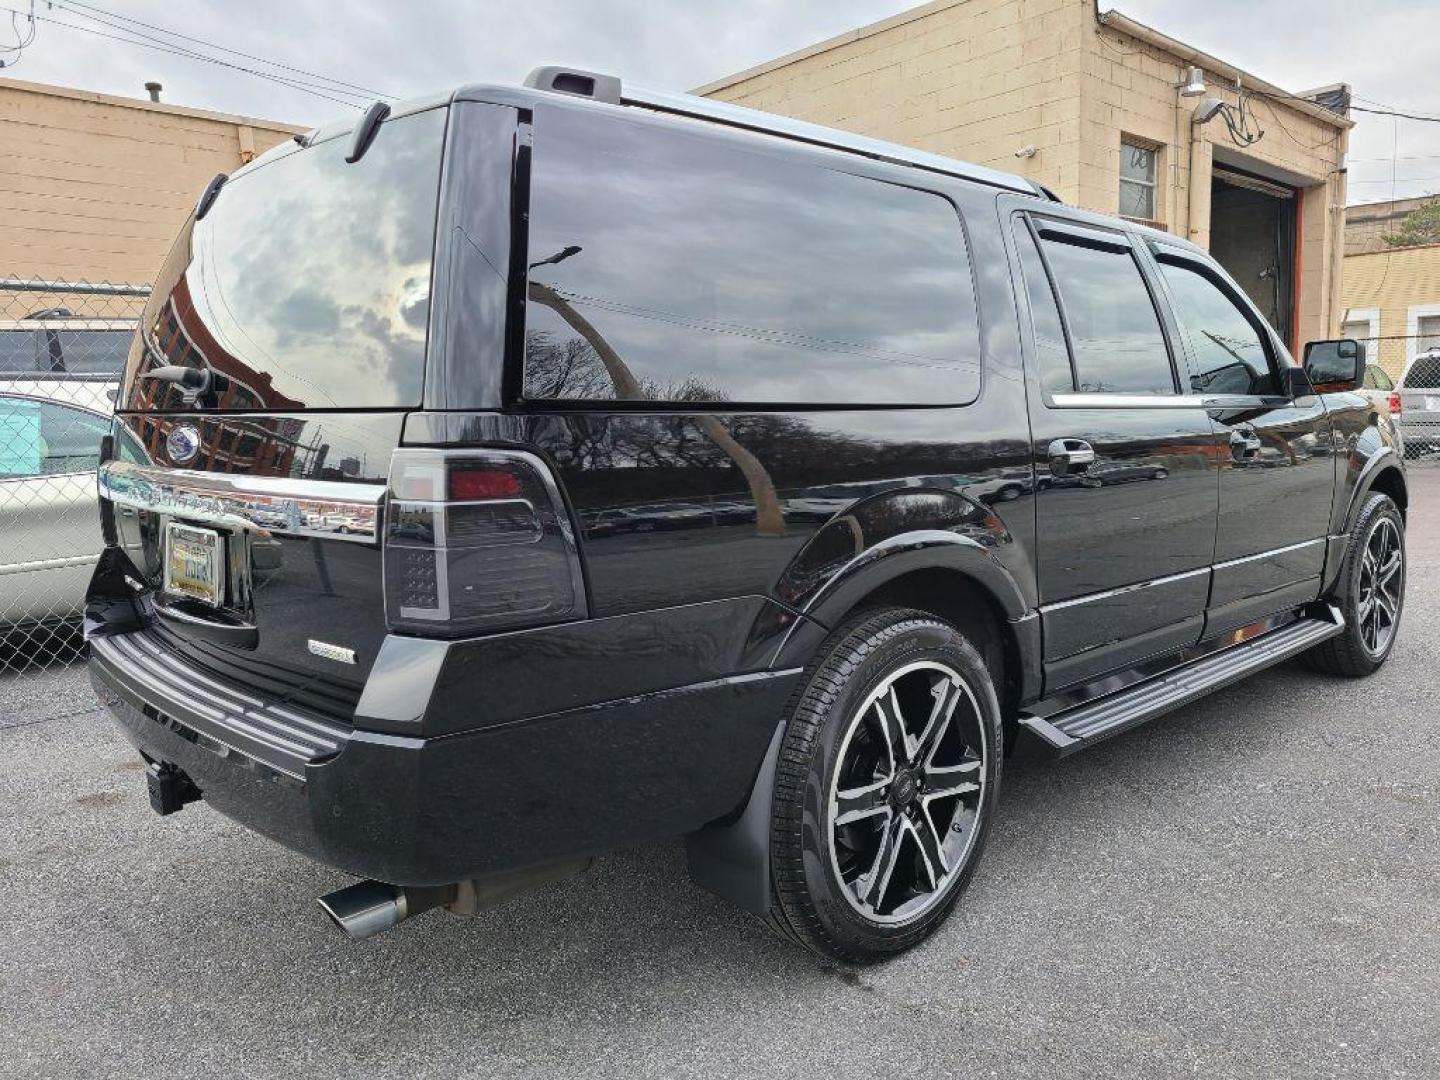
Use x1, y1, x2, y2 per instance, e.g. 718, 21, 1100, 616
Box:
91, 632, 799, 886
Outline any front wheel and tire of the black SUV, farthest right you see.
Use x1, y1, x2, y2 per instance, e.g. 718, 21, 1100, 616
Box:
1302, 492, 1405, 678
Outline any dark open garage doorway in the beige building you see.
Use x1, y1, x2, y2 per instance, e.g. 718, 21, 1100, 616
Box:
1210, 164, 1300, 351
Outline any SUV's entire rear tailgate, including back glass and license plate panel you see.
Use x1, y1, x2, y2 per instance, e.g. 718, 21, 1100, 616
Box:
92, 104, 448, 719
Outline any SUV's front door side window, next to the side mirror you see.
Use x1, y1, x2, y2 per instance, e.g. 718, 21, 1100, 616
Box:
1161, 262, 1279, 393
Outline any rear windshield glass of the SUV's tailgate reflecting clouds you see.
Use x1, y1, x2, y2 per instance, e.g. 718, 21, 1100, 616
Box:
125, 109, 445, 410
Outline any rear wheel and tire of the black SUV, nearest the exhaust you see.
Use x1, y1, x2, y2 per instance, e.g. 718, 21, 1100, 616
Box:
769, 608, 1004, 963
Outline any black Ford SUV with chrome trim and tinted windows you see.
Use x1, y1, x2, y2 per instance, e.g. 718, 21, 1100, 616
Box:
86, 69, 1405, 960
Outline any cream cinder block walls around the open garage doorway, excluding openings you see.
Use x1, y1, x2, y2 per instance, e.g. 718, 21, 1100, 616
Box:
697, 0, 1346, 341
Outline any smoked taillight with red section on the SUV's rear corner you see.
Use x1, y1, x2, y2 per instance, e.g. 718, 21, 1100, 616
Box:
384, 449, 586, 635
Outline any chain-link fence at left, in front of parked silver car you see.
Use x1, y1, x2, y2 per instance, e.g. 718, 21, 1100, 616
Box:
0, 278, 150, 674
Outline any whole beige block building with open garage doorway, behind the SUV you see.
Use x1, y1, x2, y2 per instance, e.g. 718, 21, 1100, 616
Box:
697, 0, 1351, 347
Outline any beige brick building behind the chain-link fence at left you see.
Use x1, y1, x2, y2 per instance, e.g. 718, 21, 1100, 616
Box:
0, 79, 304, 292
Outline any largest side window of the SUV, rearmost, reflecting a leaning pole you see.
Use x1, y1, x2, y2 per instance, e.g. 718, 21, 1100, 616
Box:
526, 112, 979, 403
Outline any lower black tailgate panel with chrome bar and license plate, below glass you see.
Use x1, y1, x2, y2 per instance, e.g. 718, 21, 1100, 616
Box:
101, 413, 402, 717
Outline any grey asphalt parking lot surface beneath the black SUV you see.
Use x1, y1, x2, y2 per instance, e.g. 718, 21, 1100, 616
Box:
0, 467, 1440, 1080
